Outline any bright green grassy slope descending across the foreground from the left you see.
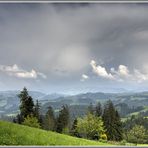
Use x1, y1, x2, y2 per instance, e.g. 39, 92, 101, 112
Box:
0, 121, 109, 146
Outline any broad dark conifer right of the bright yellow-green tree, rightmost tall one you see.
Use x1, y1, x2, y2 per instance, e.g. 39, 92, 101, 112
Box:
103, 100, 122, 141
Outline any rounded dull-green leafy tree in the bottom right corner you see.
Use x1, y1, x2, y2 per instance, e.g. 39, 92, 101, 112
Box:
128, 125, 146, 145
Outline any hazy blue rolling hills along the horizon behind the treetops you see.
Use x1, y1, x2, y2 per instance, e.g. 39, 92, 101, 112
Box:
0, 91, 148, 116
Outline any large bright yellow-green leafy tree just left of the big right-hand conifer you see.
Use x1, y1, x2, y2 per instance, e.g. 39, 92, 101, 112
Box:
77, 113, 104, 139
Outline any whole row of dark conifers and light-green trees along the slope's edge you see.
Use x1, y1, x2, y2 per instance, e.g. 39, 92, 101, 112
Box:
13, 88, 147, 145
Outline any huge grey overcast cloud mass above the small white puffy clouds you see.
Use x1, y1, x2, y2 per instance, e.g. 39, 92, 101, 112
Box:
0, 3, 148, 92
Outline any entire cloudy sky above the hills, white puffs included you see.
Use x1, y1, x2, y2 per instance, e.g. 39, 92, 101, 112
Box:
0, 3, 148, 94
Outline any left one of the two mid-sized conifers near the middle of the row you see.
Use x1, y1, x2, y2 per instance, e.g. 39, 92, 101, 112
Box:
44, 106, 55, 131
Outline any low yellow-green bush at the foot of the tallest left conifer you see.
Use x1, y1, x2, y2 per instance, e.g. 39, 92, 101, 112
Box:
22, 115, 40, 128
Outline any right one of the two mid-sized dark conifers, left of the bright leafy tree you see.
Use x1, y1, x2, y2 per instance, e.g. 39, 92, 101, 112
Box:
56, 105, 70, 133
